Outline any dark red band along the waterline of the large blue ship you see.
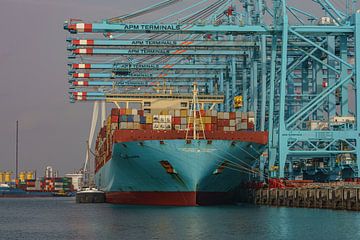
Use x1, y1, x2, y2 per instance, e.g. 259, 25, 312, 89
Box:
106, 192, 235, 206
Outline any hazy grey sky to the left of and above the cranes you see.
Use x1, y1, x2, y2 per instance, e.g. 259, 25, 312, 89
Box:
0, 0, 358, 176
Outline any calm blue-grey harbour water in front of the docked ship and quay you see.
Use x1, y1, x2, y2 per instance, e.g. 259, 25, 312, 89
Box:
0, 198, 360, 240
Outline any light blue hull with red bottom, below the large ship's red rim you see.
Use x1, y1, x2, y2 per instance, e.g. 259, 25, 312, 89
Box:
95, 140, 264, 205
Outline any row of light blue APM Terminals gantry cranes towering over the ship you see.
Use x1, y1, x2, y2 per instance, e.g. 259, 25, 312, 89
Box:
64, 0, 360, 180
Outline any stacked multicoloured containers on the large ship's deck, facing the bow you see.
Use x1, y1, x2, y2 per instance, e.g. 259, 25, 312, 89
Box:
107, 108, 255, 132
